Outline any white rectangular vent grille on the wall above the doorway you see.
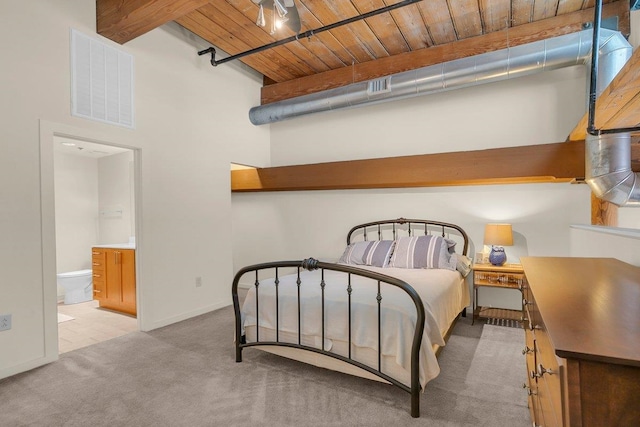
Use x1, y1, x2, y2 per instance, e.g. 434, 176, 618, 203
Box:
71, 29, 135, 128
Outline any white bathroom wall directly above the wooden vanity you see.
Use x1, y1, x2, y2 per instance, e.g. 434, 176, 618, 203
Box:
96, 151, 136, 244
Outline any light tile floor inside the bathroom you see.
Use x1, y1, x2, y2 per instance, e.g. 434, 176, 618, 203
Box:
58, 300, 138, 353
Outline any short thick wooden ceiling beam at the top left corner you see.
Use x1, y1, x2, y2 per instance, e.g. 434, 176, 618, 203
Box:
96, 0, 209, 44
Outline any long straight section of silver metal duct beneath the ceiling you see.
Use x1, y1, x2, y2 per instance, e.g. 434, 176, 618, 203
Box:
249, 30, 616, 125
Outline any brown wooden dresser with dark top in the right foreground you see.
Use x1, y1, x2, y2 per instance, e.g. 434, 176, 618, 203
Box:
521, 257, 640, 427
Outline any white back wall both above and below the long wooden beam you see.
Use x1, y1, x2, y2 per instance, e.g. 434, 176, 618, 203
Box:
233, 19, 640, 308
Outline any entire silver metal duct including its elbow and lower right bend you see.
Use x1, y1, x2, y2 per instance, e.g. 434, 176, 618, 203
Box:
249, 29, 640, 206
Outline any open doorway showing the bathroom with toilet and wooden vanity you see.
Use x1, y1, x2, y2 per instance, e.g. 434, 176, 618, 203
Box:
53, 135, 139, 353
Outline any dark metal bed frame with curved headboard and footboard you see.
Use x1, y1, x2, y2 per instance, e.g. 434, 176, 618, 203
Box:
231, 218, 469, 418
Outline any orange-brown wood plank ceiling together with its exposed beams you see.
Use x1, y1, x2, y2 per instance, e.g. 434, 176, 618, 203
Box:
96, 0, 640, 194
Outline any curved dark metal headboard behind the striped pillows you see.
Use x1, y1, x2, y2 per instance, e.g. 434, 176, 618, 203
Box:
347, 218, 469, 256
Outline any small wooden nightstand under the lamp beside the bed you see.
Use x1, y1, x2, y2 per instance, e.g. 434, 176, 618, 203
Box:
472, 264, 526, 323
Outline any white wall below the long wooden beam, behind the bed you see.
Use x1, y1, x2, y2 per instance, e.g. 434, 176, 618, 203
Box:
233, 184, 590, 308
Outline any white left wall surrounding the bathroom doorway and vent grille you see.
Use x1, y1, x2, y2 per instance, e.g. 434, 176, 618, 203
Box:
0, 0, 269, 378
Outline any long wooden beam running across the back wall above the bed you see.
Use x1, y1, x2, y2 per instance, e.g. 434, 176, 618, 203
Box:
231, 143, 585, 192
